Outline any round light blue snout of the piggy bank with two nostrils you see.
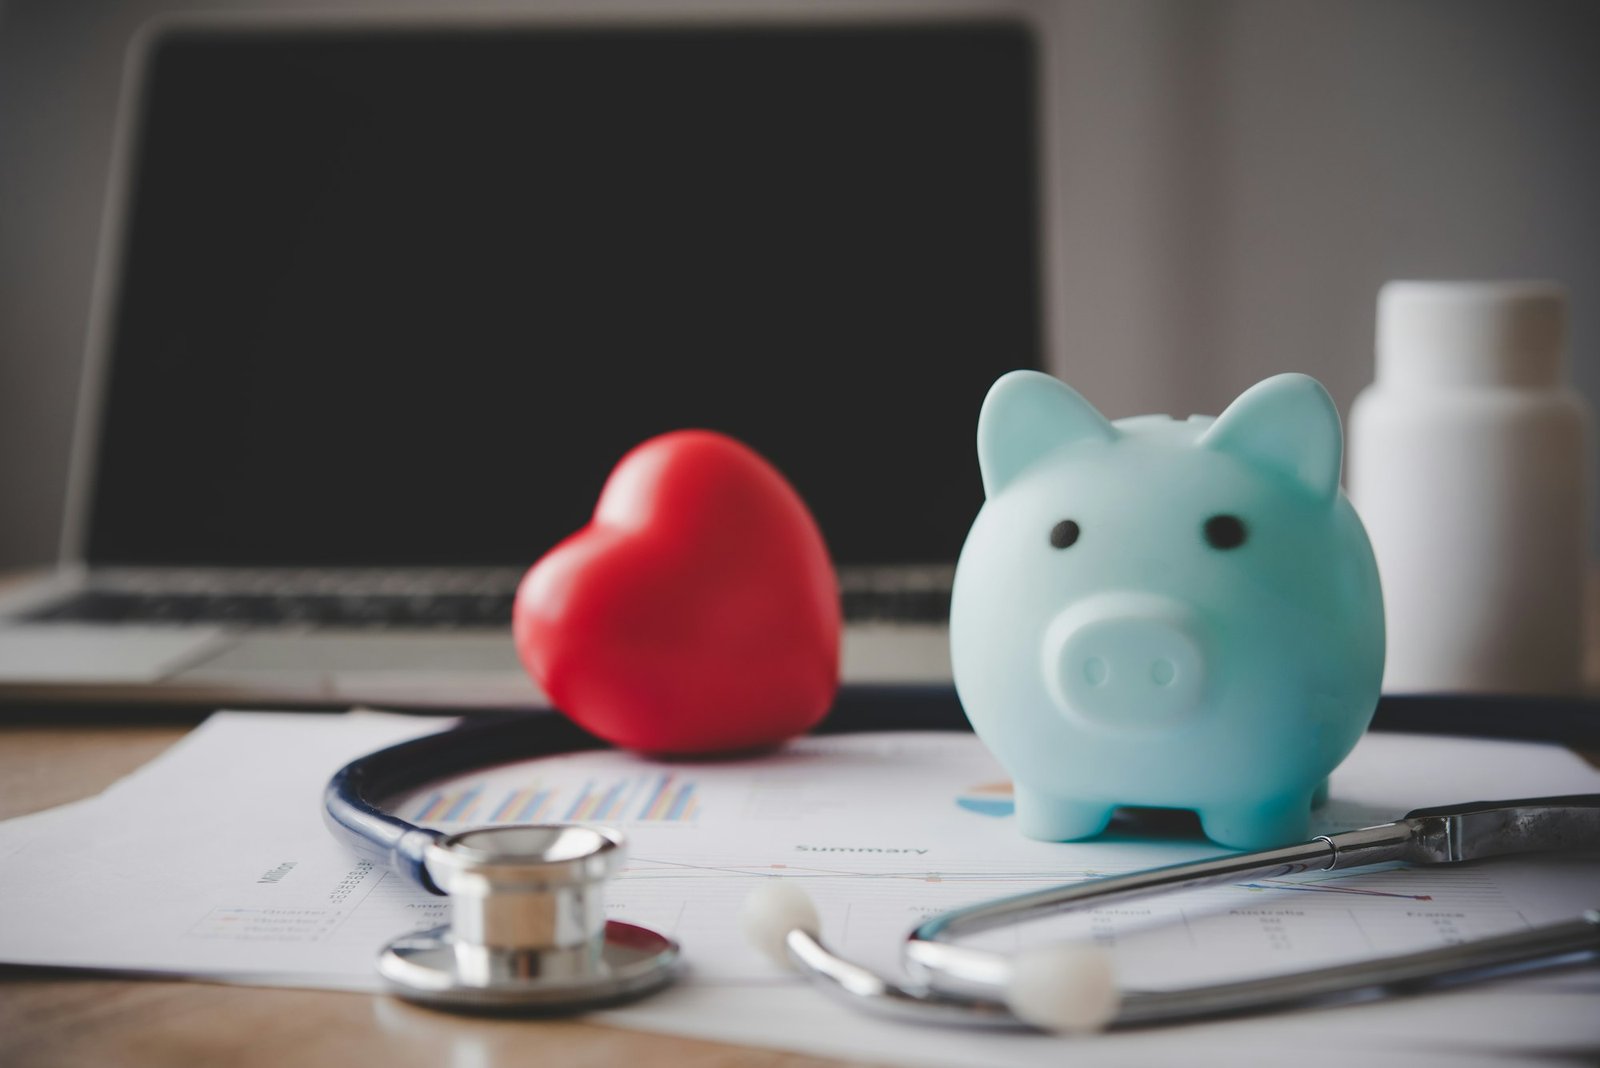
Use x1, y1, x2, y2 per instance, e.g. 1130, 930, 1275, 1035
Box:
1043, 593, 1205, 729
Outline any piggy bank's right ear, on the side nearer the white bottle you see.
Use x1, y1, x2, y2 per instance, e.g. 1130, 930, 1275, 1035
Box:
1200, 374, 1344, 500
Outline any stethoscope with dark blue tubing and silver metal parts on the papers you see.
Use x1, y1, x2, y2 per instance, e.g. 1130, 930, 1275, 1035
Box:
325, 694, 1600, 1031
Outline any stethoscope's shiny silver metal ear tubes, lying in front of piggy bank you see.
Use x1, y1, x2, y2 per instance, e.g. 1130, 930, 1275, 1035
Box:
758, 795, 1600, 1030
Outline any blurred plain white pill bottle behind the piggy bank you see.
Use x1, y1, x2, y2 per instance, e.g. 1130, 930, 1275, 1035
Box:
1349, 281, 1594, 694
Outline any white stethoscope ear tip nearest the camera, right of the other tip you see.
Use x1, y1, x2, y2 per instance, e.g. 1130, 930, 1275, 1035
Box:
1005, 942, 1122, 1034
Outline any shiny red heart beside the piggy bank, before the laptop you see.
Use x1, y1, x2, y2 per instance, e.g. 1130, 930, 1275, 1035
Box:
514, 430, 840, 753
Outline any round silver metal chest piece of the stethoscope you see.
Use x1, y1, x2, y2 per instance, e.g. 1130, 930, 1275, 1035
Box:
378, 825, 678, 1012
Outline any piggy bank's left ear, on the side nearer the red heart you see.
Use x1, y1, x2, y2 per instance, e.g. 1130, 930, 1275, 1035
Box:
978, 371, 1117, 497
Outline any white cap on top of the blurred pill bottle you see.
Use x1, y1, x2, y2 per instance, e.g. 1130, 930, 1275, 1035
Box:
1378, 281, 1566, 389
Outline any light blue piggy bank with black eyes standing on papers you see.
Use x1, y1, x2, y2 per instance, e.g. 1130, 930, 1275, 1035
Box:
950, 371, 1384, 849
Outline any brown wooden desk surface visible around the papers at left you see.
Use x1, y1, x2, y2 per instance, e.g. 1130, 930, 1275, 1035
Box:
0, 724, 862, 1068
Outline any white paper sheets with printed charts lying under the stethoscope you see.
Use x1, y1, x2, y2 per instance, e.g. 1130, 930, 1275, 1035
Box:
0, 713, 1600, 1065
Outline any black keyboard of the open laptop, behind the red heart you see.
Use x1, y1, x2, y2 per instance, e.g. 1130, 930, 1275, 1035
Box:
27, 575, 950, 630
